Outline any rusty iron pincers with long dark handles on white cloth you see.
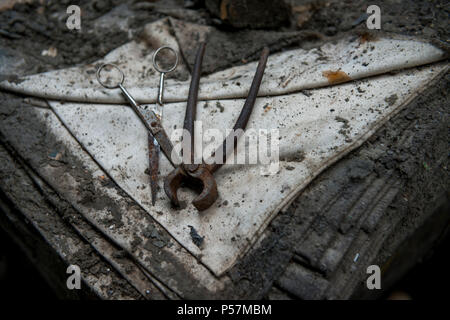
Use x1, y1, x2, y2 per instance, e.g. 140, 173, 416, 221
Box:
161, 43, 269, 211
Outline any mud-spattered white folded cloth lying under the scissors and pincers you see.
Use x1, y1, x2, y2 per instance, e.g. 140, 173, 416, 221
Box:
1, 18, 447, 275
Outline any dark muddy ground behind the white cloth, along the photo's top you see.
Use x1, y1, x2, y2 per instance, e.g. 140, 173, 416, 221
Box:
0, 0, 449, 77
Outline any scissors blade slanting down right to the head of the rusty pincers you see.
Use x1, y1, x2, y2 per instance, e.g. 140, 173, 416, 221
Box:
138, 106, 181, 167
